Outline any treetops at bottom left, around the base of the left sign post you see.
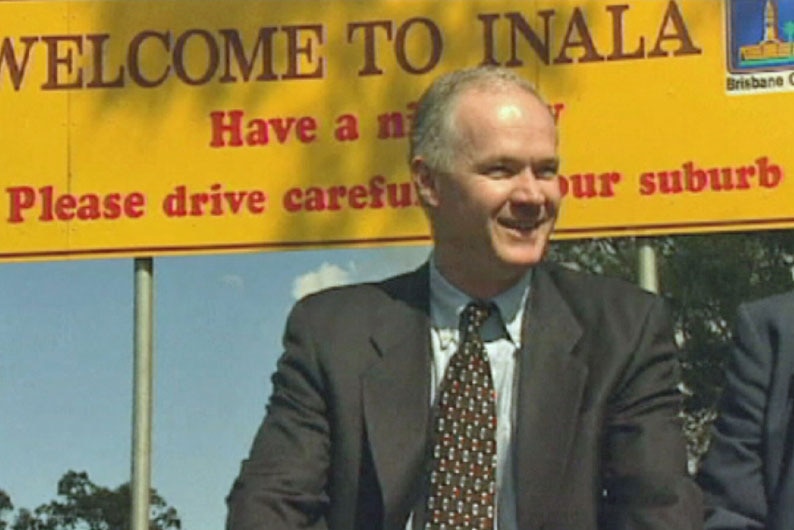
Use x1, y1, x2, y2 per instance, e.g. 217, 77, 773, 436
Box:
4, 471, 181, 530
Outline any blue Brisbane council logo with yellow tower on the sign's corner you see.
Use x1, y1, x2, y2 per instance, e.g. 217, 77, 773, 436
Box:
726, 0, 794, 93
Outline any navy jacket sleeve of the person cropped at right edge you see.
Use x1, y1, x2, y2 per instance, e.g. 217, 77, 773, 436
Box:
699, 306, 772, 530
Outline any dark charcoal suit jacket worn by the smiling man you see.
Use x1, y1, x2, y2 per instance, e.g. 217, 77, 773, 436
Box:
227, 265, 702, 530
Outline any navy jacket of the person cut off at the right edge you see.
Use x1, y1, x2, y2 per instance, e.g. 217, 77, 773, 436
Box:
699, 291, 794, 530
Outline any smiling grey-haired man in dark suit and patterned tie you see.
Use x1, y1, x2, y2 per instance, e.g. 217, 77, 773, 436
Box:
228, 68, 702, 530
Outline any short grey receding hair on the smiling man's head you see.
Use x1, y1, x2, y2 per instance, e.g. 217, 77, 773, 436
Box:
408, 66, 545, 171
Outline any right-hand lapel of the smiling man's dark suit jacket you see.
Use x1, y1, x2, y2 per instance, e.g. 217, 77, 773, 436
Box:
515, 267, 587, 528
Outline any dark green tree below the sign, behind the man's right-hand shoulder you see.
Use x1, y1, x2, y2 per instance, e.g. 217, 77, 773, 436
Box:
550, 231, 794, 461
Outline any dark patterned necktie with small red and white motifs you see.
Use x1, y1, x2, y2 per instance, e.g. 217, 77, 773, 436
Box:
425, 302, 496, 530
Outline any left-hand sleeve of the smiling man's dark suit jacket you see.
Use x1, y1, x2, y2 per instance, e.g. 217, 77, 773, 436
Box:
226, 296, 330, 530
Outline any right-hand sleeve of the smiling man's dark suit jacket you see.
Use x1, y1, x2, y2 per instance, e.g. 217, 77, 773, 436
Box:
599, 298, 703, 530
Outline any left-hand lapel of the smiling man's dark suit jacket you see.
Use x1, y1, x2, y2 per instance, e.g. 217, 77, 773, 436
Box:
362, 266, 430, 528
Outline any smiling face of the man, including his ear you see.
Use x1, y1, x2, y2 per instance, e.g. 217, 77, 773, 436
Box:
412, 85, 561, 297
